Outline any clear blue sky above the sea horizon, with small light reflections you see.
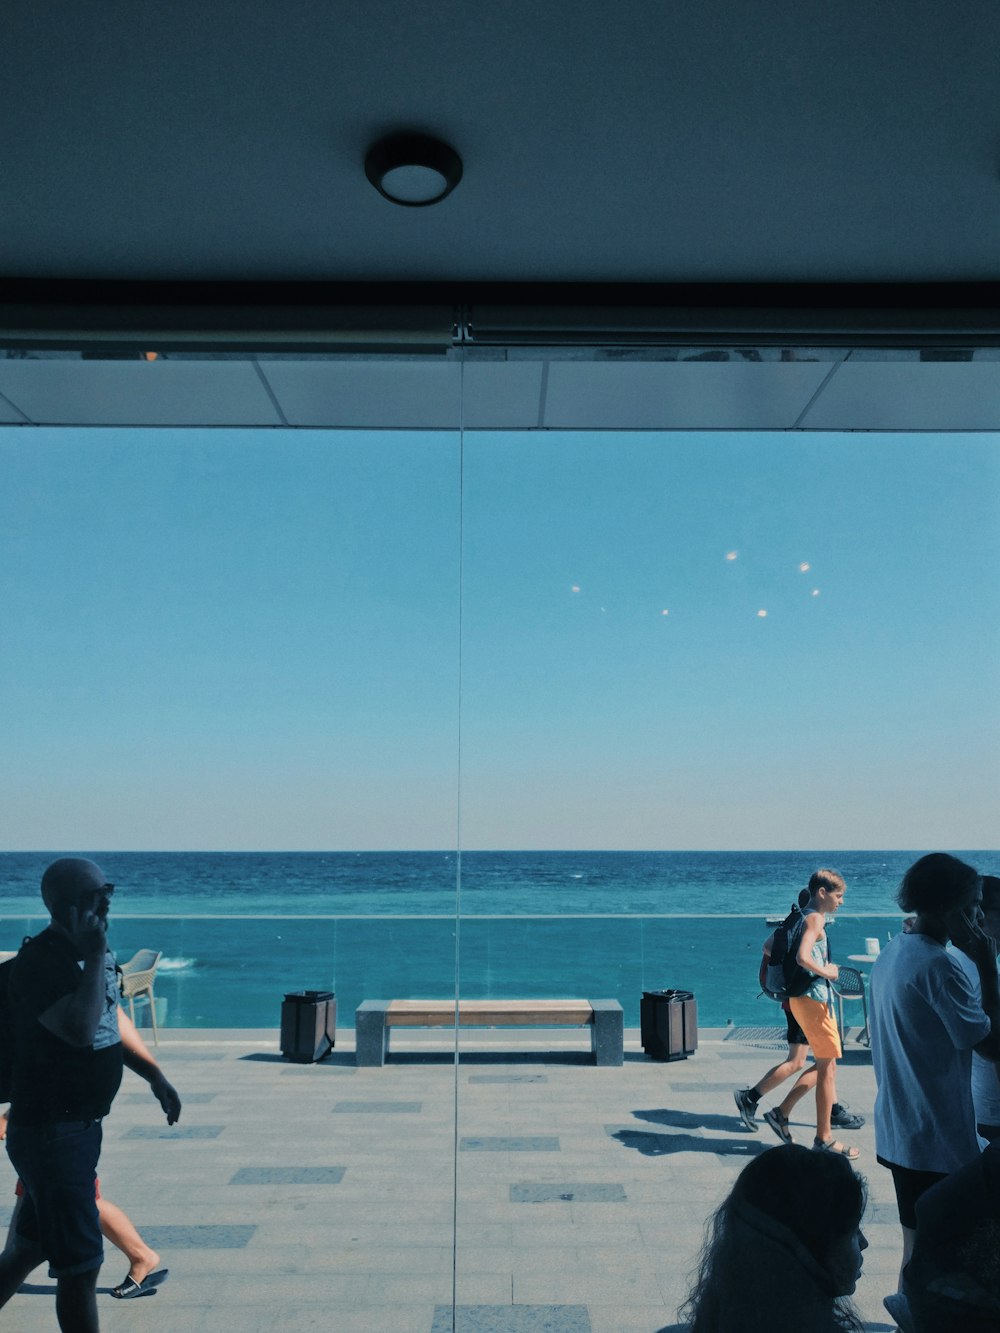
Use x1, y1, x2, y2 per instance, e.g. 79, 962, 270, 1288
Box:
0, 428, 1000, 849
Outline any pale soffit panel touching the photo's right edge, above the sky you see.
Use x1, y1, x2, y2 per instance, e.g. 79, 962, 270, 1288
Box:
803, 361, 1000, 431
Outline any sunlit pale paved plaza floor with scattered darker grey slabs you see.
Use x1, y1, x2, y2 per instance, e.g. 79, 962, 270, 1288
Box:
0, 1030, 900, 1333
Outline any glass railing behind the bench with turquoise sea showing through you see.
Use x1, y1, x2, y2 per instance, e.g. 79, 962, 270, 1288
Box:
0, 913, 900, 1028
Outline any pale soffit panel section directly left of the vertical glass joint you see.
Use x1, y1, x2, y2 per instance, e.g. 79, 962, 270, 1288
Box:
259, 360, 461, 431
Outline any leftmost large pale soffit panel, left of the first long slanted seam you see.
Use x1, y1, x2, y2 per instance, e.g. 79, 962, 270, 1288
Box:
0, 359, 280, 427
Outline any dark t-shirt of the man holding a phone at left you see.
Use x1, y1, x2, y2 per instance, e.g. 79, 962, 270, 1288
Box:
11, 926, 123, 1125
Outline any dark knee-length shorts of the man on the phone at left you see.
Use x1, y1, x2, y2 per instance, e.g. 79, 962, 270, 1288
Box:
7, 1120, 104, 1277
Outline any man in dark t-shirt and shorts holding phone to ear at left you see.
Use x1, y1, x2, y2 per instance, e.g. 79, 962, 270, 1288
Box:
0, 857, 180, 1333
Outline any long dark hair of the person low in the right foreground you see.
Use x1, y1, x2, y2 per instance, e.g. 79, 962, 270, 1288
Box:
679, 1145, 868, 1333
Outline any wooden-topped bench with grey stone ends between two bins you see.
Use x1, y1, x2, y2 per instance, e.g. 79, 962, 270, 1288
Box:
355, 1000, 624, 1066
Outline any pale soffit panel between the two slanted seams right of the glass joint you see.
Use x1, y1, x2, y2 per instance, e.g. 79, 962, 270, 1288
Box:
545, 361, 831, 431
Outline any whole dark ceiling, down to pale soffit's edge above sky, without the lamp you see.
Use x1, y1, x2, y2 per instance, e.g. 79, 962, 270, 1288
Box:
0, 0, 1000, 429
